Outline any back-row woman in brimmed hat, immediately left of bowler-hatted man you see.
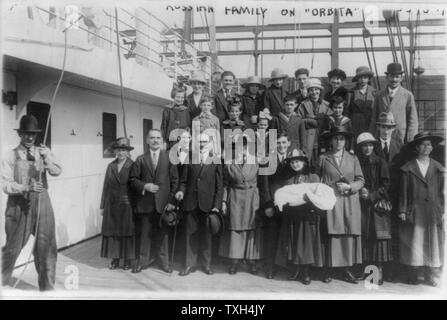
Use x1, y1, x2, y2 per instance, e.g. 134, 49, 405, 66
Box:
346, 66, 376, 136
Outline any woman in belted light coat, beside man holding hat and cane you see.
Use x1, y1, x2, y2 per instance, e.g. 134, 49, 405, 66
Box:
219, 143, 262, 274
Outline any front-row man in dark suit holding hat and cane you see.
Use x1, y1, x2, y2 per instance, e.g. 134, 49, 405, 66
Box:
176, 134, 223, 276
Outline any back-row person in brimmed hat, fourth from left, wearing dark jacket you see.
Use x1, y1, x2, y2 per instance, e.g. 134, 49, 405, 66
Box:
264, 68, 289, 122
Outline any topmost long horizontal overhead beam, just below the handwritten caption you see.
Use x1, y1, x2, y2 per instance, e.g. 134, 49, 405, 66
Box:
166, 19, 446, 35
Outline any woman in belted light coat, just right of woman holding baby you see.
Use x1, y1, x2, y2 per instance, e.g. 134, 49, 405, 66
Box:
319, 127, 364, 283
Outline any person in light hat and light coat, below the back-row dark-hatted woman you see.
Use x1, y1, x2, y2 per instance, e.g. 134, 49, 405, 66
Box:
297, 78, 332, 170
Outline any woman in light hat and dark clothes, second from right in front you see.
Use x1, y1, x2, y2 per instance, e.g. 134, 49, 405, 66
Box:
357, 132, 393, 285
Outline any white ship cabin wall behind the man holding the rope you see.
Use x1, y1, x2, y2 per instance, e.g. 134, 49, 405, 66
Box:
2, 80, 163, 248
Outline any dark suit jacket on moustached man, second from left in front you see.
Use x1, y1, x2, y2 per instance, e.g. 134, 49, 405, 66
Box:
130, 150, 179, 213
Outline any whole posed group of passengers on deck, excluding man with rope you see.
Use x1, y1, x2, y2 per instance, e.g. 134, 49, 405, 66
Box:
97, 63, 444, 286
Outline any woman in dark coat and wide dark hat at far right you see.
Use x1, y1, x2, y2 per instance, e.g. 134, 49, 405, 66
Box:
398, 132, 445, 286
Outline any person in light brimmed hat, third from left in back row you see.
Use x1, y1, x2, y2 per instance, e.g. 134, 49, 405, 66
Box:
242, 76, 265, 129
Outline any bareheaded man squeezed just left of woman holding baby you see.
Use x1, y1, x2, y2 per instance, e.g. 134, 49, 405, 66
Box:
260, 133, 290, 279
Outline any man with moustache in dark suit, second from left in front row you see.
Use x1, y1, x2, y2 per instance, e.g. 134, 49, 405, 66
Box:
129, 129, 179, 273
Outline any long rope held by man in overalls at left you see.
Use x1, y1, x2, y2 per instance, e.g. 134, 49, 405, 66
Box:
12, 24, 67, 288
